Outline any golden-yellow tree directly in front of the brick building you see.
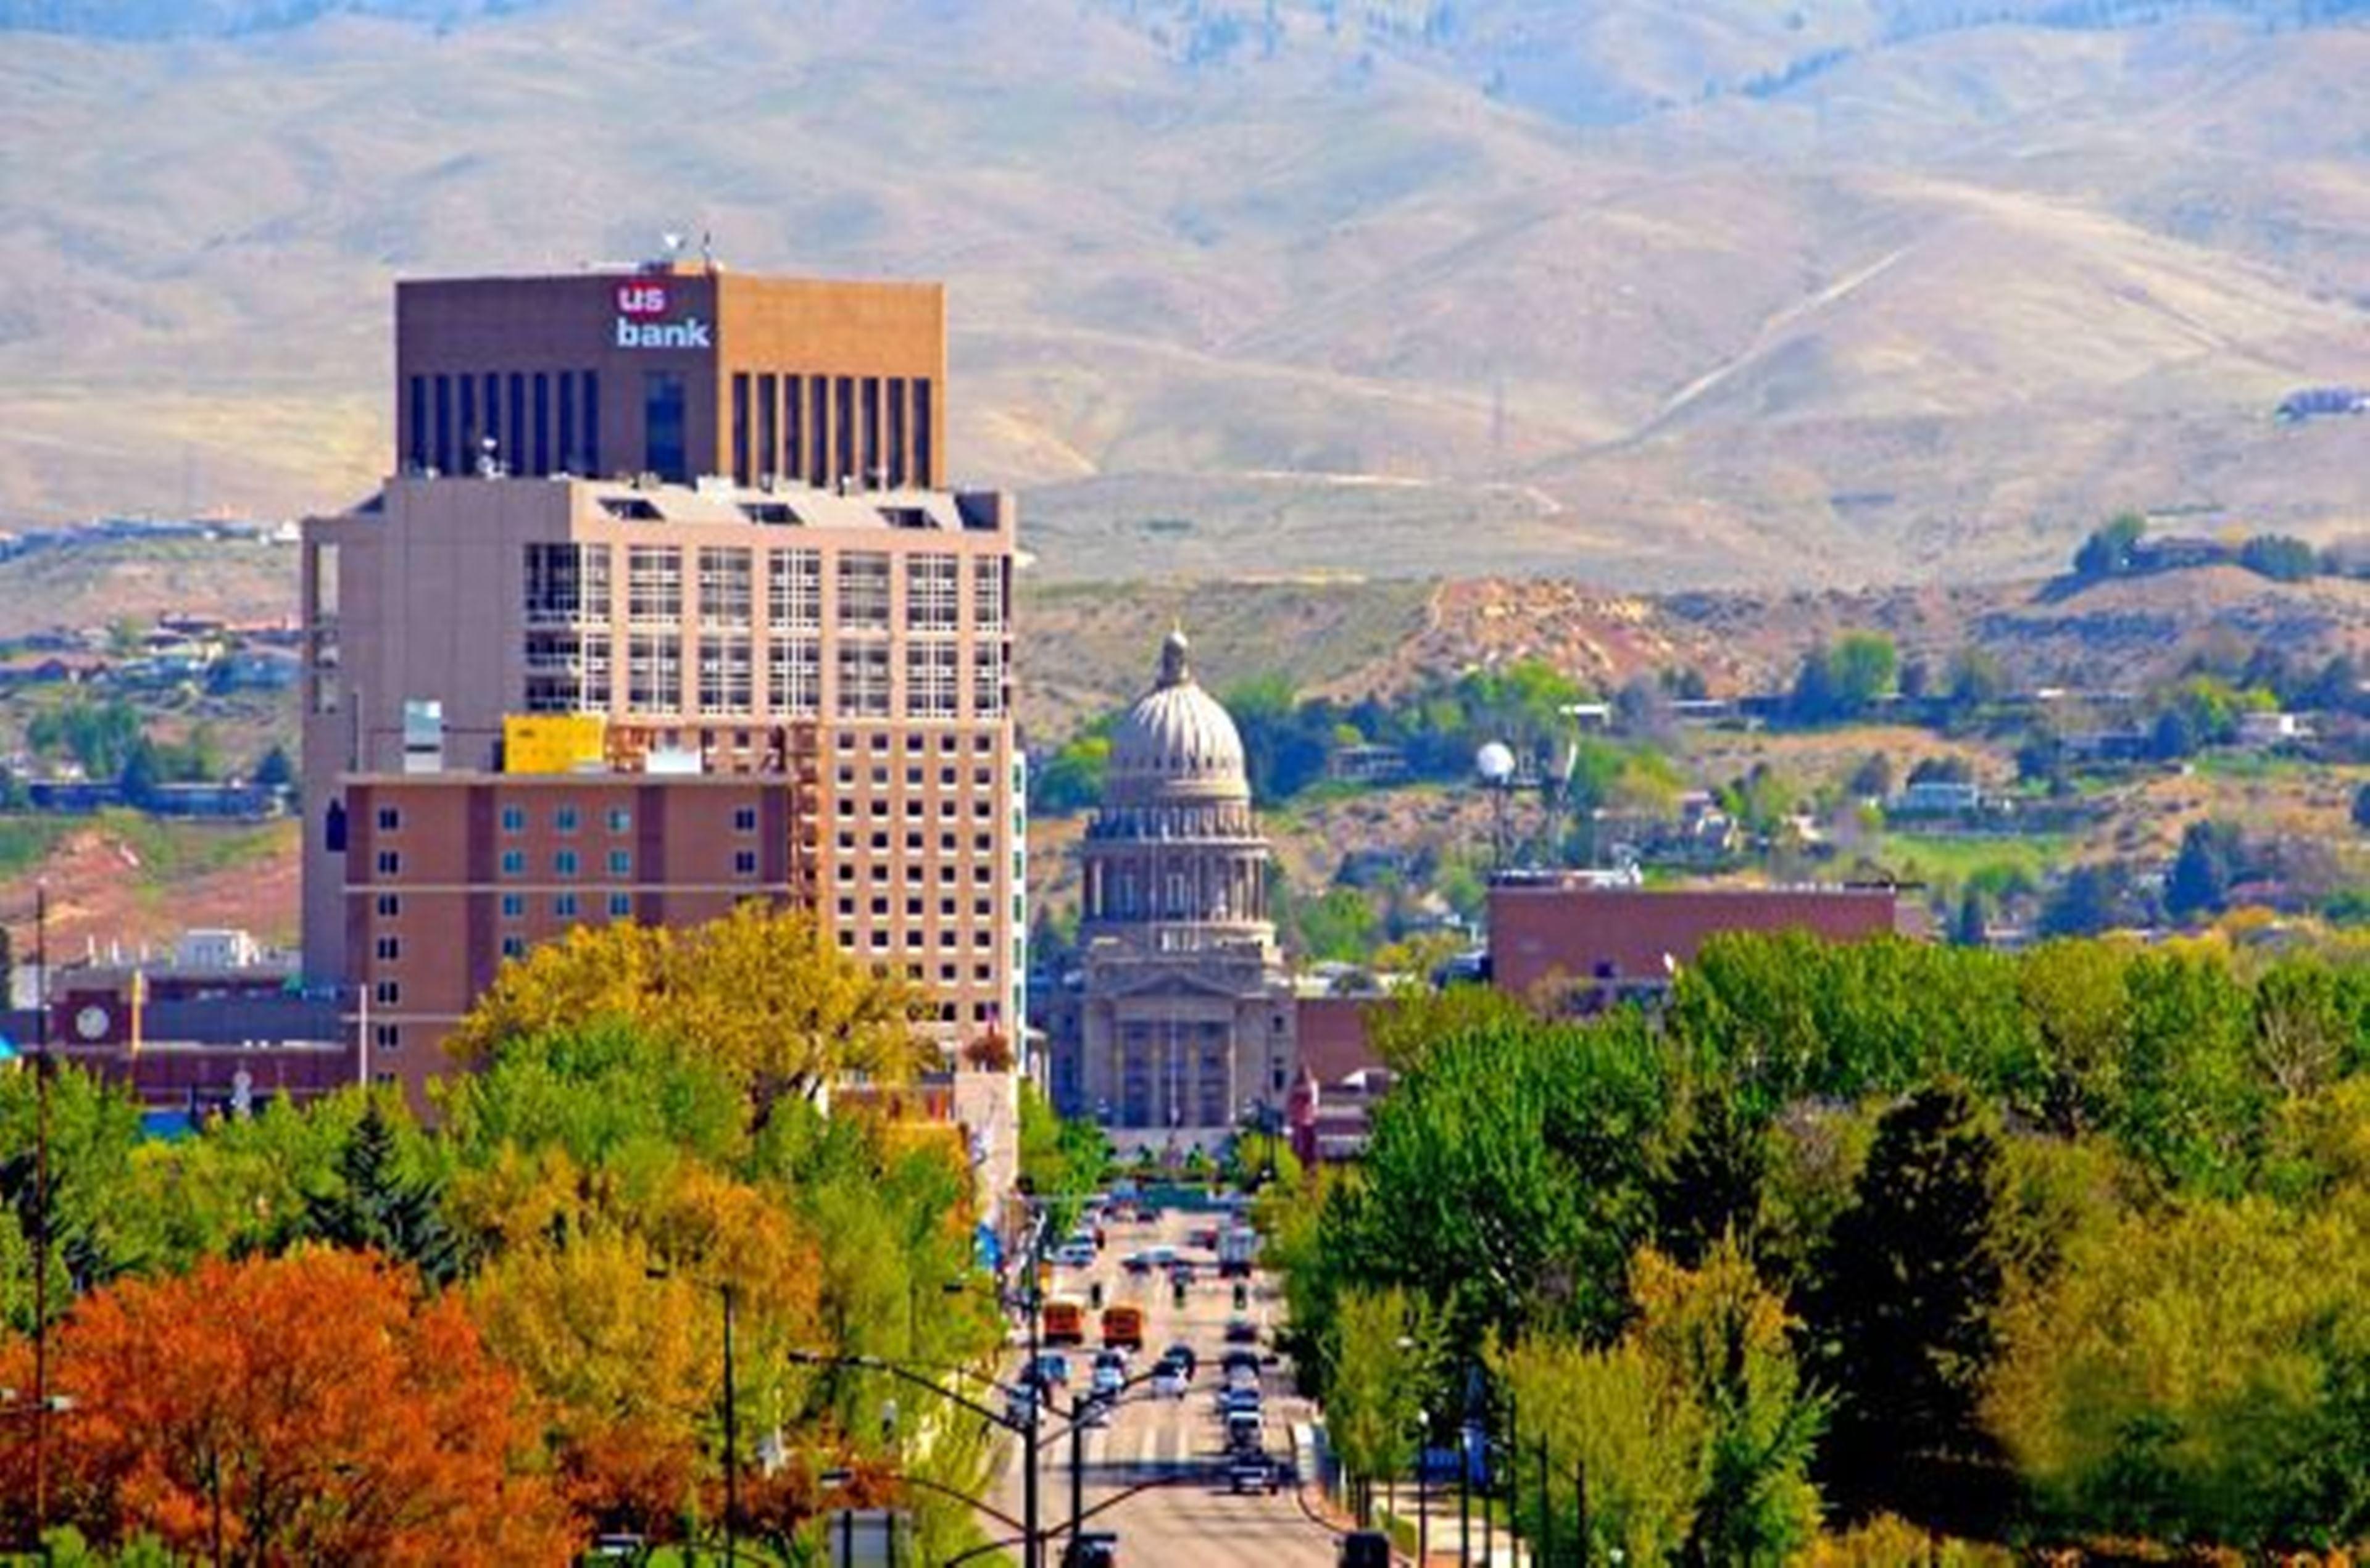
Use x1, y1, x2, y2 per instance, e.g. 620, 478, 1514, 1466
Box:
448, 900, 922, 1122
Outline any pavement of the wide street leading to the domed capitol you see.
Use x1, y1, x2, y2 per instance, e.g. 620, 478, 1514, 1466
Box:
993, 1213, 1334, 1568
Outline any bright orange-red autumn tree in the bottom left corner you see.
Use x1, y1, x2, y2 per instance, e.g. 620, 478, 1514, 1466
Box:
0, 1248, 578, 1566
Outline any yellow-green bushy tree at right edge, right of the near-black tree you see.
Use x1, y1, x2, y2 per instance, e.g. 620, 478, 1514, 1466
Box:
1986, 1187, 2370, 1549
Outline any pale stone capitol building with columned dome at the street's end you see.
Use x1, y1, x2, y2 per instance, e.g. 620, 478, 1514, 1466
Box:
1038, 630, 1294, 1144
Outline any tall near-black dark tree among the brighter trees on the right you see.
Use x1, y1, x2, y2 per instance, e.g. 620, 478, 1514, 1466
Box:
1808, 1085, 2007, 1523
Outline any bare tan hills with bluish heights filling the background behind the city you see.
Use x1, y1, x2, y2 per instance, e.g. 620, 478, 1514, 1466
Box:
0, 0, 2370, 587
